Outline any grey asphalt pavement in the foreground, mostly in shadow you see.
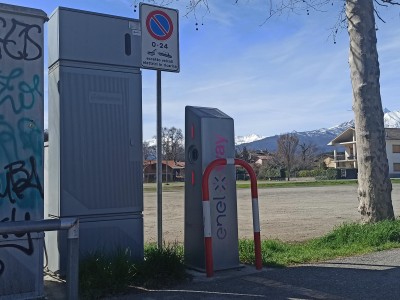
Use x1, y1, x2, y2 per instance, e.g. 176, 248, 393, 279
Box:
45, 249, 400, 300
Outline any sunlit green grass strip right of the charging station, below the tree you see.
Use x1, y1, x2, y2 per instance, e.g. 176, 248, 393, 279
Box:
239, 220, 400, 267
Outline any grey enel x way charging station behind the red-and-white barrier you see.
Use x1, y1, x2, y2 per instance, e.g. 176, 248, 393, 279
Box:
184, 106, 239, 270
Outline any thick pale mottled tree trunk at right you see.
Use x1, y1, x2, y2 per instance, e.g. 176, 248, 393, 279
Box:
346, 0, 394, 222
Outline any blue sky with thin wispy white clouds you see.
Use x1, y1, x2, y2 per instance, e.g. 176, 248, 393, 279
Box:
7, 0, 400, 140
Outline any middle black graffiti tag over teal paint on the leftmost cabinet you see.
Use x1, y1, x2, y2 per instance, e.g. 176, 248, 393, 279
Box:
0, 156, 44, 203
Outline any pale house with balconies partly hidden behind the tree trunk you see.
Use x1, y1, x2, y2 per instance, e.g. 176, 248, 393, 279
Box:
325, 128, 400, 177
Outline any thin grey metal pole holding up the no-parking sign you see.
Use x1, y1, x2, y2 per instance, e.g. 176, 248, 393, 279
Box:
157, 70, 162, 249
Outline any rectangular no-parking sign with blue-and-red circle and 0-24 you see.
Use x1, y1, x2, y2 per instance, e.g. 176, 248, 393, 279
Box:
139, 3, 179, 72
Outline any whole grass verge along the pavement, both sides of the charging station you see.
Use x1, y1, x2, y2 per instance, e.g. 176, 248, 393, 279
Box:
79, 220, 400, 299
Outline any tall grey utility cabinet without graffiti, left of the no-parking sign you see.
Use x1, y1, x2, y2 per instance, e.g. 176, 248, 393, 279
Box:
46, 7, 143, 274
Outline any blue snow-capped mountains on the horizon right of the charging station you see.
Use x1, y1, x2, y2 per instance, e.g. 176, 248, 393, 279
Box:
236, 108, 400, 152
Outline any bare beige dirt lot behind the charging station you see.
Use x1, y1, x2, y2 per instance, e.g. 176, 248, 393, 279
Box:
143, 184, 400, 243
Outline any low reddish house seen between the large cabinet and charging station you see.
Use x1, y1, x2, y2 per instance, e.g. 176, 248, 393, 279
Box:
143, 160, 185, 183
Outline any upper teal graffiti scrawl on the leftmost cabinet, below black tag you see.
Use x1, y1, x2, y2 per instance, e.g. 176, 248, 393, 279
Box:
0, 68, 43, 114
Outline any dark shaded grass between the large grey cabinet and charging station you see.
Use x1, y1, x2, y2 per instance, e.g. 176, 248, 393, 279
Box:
79, 243, 190, 299
